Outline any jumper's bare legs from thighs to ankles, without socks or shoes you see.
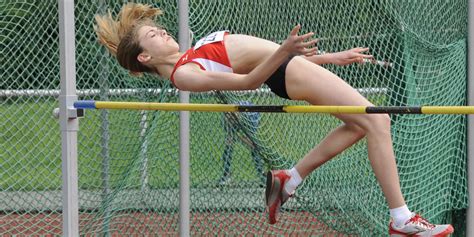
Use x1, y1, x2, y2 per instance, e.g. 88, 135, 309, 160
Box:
286, 57, 405, 208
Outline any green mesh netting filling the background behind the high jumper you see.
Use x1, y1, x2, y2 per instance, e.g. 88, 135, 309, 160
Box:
0, 0, 468, 236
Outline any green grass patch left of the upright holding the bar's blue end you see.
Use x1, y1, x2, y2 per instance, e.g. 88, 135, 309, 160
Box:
0, 102, 61, 191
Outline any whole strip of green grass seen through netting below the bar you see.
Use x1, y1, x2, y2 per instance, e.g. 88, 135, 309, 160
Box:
0, 94, 386, 191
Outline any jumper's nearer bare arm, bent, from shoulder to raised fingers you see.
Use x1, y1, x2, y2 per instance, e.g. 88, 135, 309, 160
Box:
174, 25, 317, 91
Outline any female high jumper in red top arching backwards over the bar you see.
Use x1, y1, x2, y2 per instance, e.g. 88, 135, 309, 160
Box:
95, 3, 454, 236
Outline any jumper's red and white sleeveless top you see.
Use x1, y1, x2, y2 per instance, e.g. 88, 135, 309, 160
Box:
170, 31, 232, 86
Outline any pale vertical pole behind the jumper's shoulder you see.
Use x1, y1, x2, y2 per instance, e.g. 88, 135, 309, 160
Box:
178, 0, 191, 237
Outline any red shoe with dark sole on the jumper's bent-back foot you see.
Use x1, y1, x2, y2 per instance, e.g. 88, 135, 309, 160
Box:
265, 170, 291, 224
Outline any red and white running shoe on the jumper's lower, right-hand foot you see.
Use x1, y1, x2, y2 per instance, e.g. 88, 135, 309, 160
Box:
388, 213, 454, 237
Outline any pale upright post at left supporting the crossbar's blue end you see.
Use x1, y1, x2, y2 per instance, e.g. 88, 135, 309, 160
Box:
59, 0, 79, 236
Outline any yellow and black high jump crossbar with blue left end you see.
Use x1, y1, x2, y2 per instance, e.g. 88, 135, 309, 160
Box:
74, 100, 474, 114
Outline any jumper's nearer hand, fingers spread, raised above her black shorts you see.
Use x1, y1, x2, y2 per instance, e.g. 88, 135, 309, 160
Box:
280, 24, 318, 57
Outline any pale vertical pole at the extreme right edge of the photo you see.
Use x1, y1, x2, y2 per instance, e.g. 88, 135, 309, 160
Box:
466, 0, 474, 236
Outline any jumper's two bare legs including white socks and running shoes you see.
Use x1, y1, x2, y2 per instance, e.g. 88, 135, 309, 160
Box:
265, 57, 454, 233
